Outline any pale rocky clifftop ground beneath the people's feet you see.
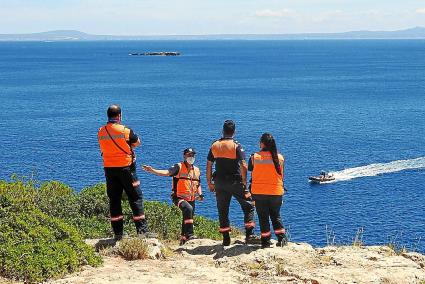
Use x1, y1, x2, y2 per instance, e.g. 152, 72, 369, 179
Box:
47, 239, 425, 284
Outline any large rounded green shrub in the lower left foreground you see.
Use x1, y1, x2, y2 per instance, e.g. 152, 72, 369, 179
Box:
0, 182, 101, 282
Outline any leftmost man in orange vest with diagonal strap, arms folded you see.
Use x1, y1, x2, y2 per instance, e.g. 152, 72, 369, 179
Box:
97, 105, 153, 240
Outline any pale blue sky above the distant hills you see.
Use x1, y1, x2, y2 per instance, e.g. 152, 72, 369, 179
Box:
0, 0, 425, 35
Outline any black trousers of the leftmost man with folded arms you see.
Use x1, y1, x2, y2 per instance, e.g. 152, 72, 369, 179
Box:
105, 164, 147, 235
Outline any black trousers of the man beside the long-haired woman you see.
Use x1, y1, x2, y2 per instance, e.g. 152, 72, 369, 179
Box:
215, 180, 255, 236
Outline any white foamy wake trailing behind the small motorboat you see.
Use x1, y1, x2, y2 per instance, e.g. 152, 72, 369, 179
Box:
331, 157, 425, 182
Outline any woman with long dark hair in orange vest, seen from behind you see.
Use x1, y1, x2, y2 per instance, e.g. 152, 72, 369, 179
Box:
248, 133, 288, 248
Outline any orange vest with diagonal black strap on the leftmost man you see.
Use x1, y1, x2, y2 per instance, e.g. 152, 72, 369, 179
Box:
97, 123, 133, 168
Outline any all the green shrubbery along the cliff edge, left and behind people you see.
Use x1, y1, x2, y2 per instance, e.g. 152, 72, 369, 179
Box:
0, 176, 220, 282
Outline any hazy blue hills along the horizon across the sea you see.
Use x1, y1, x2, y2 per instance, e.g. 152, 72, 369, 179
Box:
0, 27, 425, 41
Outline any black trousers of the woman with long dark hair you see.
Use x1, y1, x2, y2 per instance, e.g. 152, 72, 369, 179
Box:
252, 194, 285, 240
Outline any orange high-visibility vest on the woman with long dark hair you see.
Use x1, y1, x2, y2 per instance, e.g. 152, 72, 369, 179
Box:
251, 151, 284, 195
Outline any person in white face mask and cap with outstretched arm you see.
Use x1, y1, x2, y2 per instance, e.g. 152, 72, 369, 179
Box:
142, 148, 204, 245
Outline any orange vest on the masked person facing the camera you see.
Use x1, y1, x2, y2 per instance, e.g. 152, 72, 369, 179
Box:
173, 162, 201, 201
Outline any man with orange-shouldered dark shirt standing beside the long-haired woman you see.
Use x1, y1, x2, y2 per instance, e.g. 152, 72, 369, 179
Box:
206, 120, 259, 246
